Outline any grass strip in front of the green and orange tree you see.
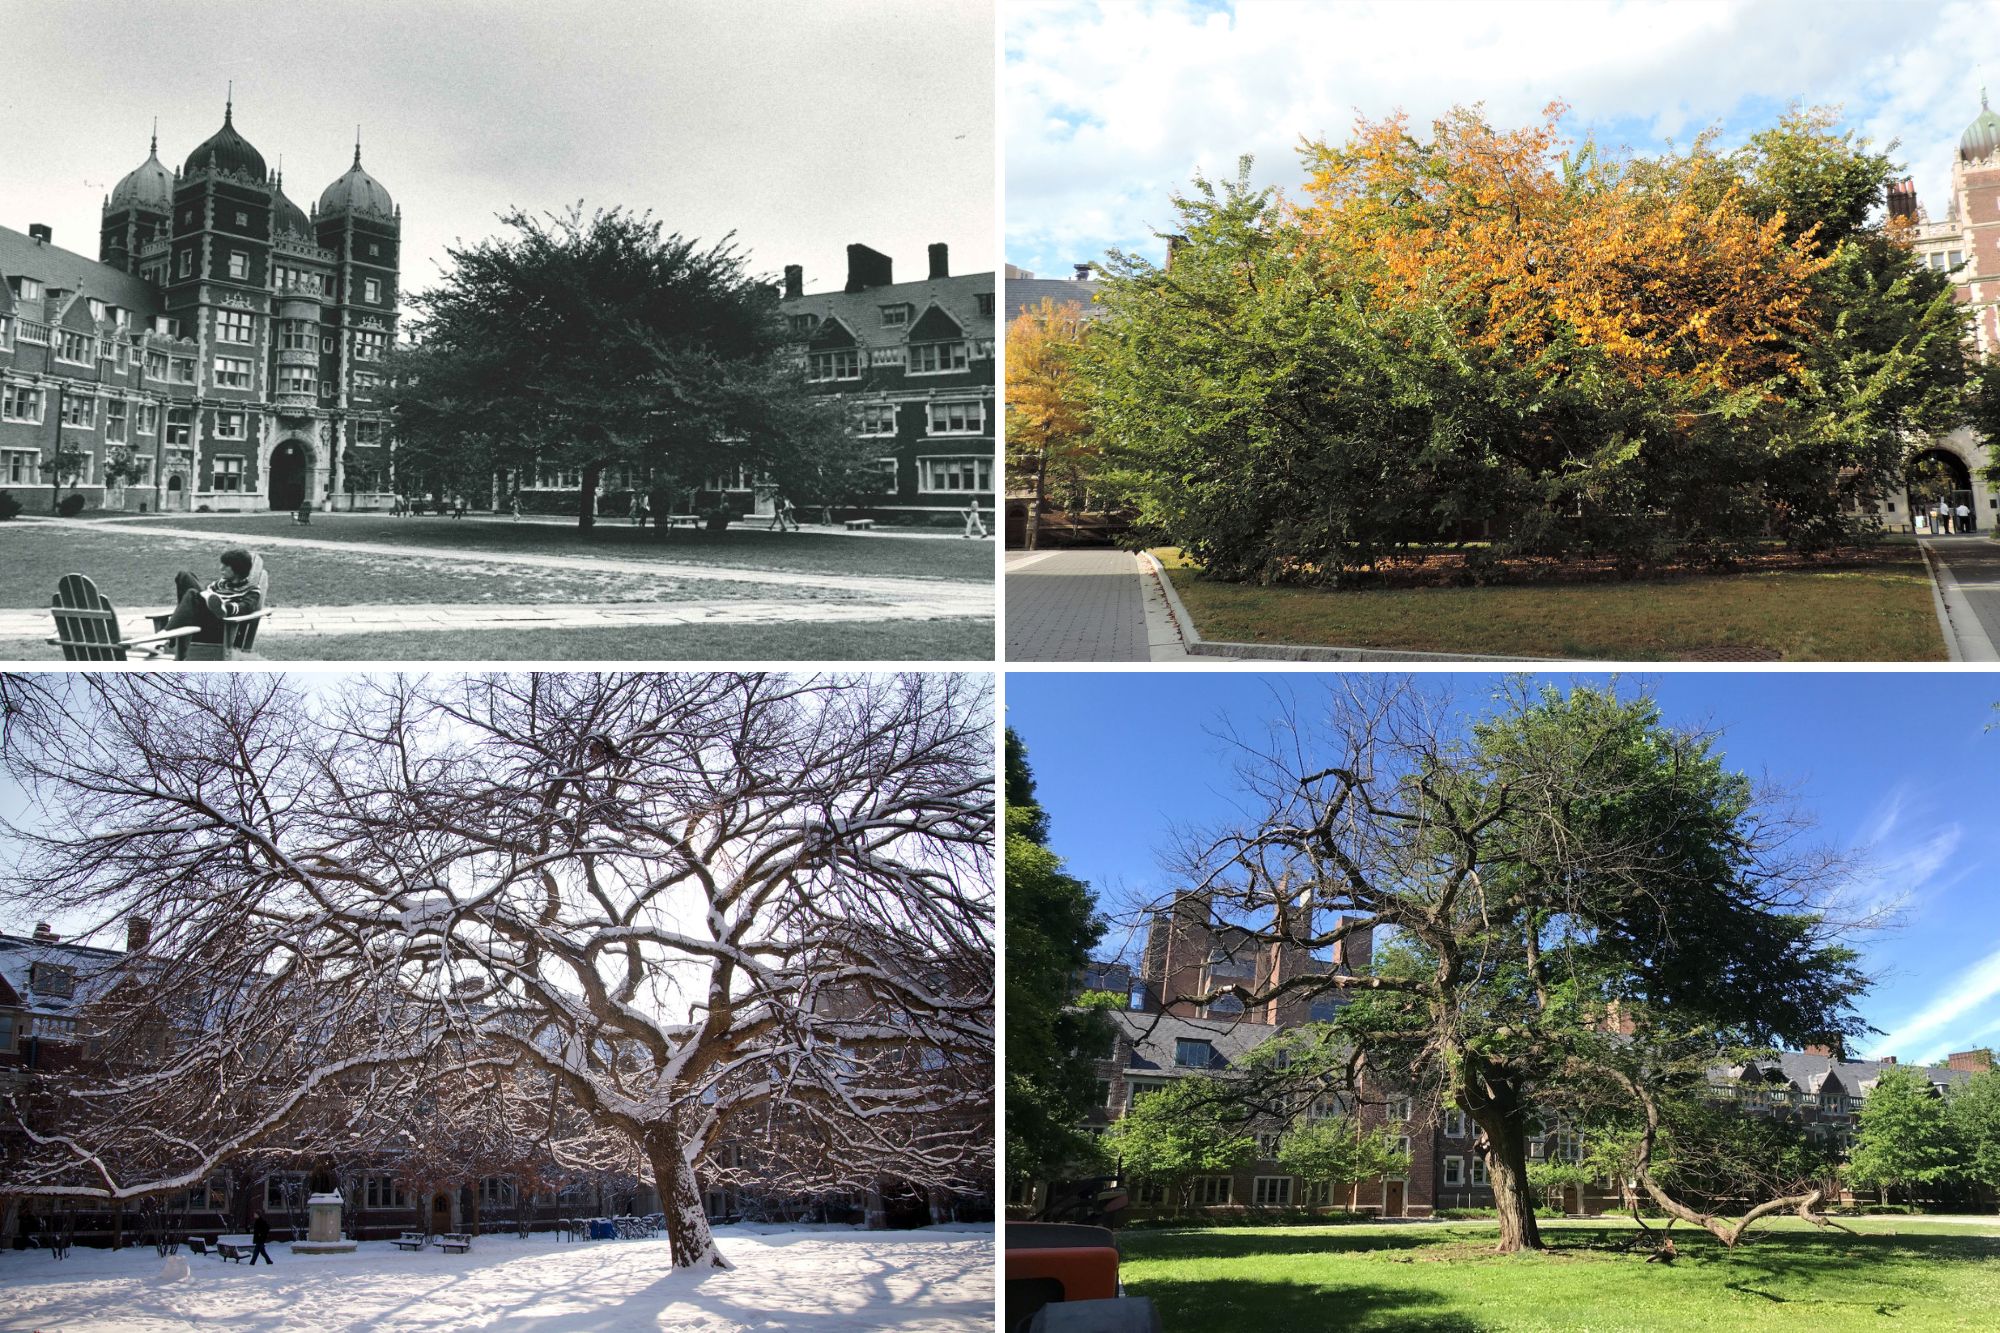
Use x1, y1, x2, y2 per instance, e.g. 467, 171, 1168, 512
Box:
1154, 544, 1946, 662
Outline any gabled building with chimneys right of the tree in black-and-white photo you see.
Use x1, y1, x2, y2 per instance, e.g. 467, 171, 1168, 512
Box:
780, 244, 998, 520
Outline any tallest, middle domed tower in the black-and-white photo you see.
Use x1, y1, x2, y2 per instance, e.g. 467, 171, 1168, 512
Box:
162, 96, 278, 508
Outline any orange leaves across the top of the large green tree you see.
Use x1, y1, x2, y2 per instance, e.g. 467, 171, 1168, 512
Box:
1290, 104, 1830, 392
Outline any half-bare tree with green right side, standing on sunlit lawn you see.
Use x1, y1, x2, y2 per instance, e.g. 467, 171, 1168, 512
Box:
1144, 677, 1864, 1249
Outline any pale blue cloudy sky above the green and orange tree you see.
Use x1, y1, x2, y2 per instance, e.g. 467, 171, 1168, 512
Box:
1002, 0, 2000, 276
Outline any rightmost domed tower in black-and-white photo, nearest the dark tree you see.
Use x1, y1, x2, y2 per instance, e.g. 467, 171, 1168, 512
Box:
312, 132, 402, 504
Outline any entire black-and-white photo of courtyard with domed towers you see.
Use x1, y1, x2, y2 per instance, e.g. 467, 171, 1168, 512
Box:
0, 0, 998, 662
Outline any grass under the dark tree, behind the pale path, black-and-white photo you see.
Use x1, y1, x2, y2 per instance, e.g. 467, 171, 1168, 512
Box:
105, 512, 994, 582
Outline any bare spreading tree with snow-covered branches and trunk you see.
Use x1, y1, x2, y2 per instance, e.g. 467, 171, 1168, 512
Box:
4, 673, 994, 1267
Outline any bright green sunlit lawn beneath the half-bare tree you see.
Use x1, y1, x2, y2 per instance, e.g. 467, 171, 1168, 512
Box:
1120, 1219, 2000, 1333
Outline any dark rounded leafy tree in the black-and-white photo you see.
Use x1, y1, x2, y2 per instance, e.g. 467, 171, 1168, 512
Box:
390, 208, 856, 526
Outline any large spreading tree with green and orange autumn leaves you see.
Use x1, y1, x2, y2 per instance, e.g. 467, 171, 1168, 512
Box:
1082, 106, 1970, 582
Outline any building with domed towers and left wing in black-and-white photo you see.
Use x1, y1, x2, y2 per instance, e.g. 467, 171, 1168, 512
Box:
0, 106, 402, 510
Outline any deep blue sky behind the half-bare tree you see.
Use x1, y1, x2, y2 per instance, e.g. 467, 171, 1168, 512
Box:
1006, 671, 2000, 1061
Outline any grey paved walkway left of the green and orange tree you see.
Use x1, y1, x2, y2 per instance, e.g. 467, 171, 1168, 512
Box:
1006, 550, 1186, 662
